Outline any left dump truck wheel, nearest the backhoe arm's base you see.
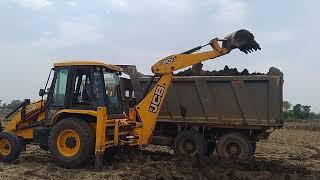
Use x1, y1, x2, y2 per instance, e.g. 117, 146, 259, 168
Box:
174, 131, 208, 156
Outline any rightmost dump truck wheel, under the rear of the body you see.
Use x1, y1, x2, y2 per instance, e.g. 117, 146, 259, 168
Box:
217, 133, 252, 160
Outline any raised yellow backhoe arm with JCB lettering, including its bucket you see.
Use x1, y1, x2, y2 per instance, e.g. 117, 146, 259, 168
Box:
130, 30, 261, 144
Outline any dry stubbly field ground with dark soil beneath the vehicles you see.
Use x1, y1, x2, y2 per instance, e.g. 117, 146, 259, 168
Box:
0, 129, 320, 180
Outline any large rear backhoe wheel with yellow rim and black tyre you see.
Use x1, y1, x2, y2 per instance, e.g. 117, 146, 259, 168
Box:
49, 118, 94, 168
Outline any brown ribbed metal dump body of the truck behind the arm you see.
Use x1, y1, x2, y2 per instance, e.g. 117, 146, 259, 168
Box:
120, 66, 283, 129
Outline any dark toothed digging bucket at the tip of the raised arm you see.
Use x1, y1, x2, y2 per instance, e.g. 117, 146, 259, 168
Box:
222, 29, 261, 54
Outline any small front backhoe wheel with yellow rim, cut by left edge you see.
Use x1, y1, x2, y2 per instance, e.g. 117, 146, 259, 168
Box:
0, 132, 22, 162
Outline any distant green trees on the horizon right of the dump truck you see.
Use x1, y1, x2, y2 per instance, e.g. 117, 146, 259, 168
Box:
283, 101, 320, 121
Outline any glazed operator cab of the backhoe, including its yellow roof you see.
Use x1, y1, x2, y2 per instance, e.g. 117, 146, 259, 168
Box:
39, 62, 123, 119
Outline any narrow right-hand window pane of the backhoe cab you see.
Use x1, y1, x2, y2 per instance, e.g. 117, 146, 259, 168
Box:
103, 71, 122, 114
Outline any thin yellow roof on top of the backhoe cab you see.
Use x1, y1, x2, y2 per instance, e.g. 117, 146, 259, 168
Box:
53, 61, 123, 72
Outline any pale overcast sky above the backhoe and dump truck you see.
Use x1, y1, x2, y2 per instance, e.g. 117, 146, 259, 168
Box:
0, 0, 320, 112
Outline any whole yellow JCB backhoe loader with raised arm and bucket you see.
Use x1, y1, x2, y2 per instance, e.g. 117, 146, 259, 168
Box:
0, 30, 260, 168
